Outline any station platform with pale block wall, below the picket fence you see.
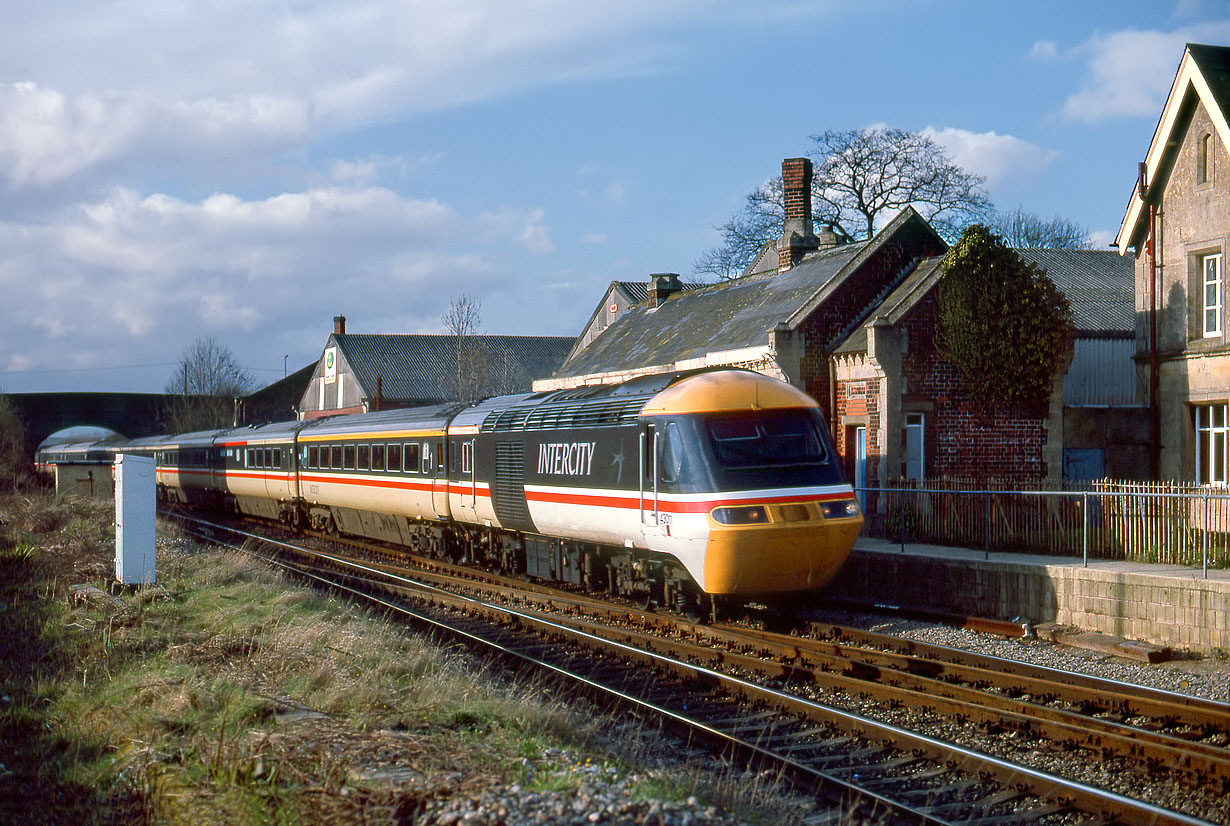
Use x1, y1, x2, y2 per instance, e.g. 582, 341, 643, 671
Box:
825, 537, 1230, 654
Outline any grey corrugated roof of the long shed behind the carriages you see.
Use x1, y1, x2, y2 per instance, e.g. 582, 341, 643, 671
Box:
331, 333, 576, 403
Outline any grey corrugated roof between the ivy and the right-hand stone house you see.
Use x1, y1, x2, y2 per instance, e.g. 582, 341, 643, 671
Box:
1017, 250, 1135, 333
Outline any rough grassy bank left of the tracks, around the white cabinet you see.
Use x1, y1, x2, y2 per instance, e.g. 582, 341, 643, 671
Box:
0, 497, 826, 826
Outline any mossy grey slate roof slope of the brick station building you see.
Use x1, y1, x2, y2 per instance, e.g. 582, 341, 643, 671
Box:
557, 243, 866, 376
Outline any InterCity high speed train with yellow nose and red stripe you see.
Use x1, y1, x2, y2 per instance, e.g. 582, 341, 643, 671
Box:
74, 369, 862, 612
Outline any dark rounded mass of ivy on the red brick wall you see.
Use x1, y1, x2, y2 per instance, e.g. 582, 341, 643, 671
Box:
936, 224, 1073, 415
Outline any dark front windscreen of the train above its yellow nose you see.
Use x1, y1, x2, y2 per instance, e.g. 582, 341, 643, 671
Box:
706, 409, 829, 470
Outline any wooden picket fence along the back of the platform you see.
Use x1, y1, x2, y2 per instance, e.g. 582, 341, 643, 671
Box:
862, 479, 1230, 568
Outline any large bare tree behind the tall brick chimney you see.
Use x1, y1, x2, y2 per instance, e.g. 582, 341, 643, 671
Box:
695, 127, 993, 278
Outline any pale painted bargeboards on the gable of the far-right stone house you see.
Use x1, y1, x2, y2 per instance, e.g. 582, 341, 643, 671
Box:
1114, 43, 1230, 248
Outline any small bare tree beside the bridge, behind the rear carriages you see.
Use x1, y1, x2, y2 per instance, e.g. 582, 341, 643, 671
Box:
164, 336, 256, 433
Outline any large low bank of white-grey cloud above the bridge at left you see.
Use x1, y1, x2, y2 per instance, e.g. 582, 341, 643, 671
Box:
0, 187, 552, 384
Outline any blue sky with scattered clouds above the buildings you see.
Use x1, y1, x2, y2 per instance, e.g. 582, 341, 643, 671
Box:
0, 0, 1230, 393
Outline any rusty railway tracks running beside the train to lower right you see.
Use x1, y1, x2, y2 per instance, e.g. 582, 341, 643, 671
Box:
178, 513, 1230, 825
